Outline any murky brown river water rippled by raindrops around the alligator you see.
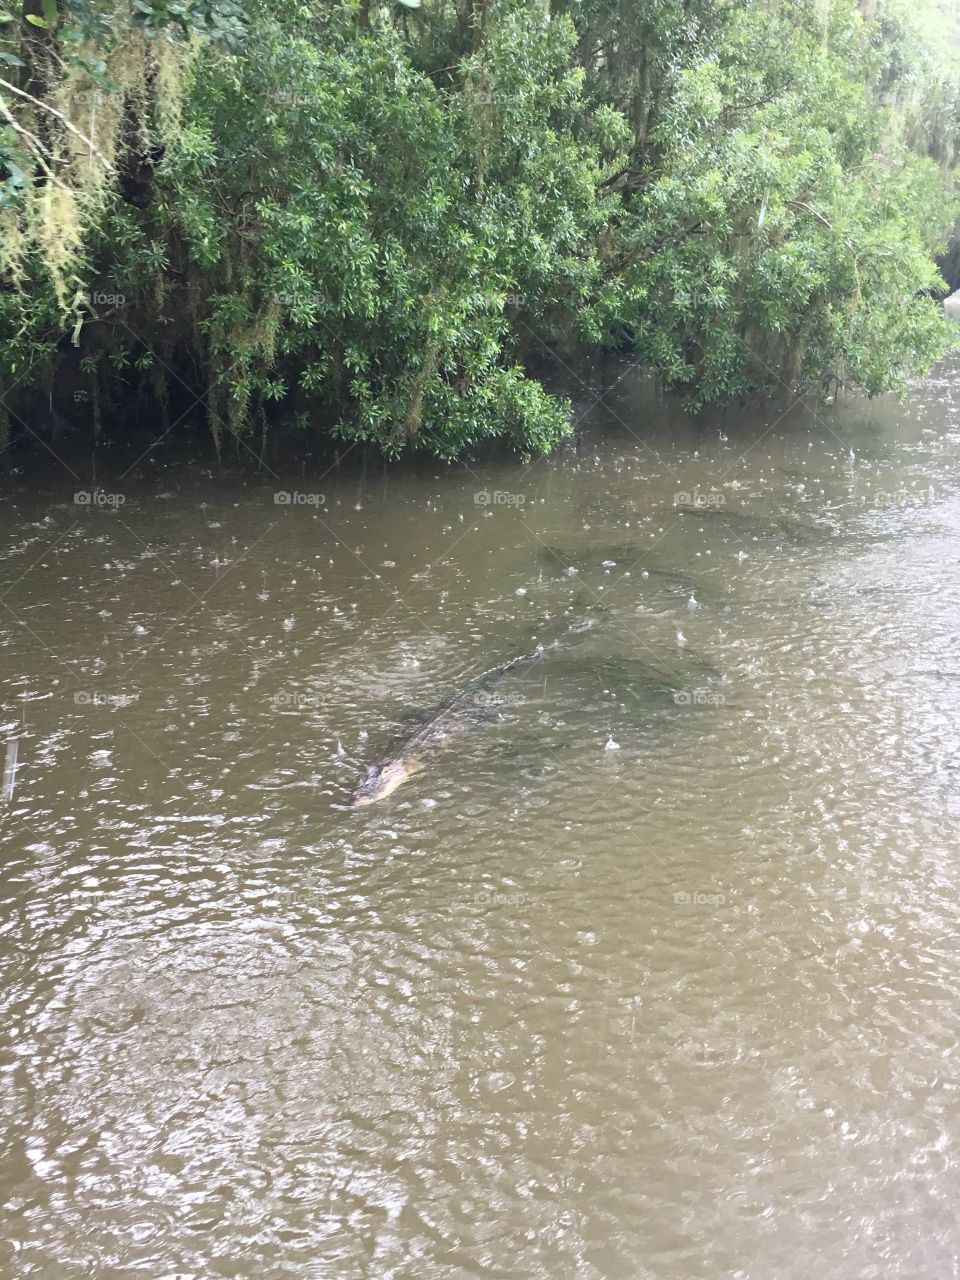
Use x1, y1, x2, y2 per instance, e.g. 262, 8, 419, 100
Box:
0, 353, 960, 1280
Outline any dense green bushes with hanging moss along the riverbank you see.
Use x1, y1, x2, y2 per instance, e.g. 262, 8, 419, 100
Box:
0, 0, 960, 457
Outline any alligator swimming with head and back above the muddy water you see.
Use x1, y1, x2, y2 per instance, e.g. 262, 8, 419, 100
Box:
349, 645, 544, 806
